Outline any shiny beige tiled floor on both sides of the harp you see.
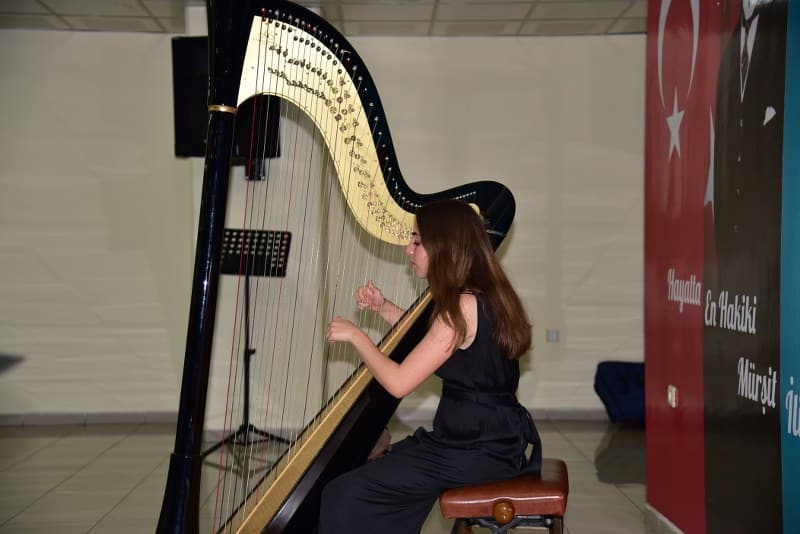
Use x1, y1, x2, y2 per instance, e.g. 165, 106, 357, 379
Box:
0, 421, 646, 534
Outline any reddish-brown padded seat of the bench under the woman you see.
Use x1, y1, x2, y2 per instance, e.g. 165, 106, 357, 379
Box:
439, 458, 569, 534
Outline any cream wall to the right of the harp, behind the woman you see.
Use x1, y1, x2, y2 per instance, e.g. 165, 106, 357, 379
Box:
353, 35, 645, 417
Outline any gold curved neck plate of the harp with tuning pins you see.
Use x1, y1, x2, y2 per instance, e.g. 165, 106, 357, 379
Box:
238, 14, 414, 245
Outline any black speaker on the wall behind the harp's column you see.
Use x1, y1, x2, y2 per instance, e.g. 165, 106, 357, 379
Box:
172, 36, 280, 179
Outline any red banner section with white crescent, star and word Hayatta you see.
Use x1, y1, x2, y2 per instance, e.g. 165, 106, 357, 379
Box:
645, 0, 727, 533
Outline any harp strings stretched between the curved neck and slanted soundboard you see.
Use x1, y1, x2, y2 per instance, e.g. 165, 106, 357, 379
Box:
209, 12, 423, 530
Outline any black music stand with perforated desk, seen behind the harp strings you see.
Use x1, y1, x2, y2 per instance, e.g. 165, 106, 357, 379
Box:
203, 228, 291, 458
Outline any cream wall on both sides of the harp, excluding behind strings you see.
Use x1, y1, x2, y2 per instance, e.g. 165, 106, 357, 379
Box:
0, 30, 645, 423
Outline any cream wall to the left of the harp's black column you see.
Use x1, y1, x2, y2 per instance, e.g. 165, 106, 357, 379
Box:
0, 30, 193, 421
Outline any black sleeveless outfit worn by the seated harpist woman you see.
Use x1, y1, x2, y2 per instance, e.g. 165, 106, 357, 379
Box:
319, 296, 542, 534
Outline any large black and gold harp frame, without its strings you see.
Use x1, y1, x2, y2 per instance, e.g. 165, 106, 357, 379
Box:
157, 0, 515, 534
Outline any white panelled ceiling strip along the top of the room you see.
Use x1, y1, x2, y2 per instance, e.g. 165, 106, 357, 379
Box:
0, 0, 647, 36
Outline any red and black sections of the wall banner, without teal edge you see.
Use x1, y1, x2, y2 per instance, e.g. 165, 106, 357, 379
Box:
645, 0, 787, 533
